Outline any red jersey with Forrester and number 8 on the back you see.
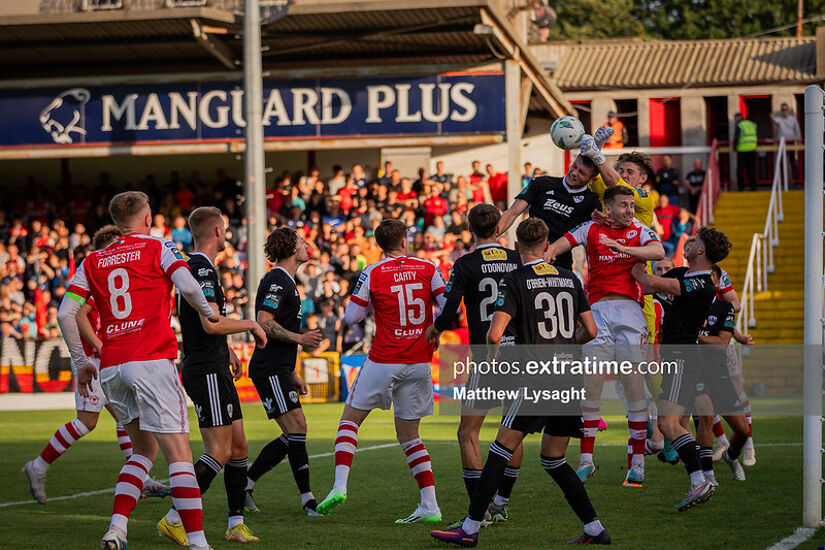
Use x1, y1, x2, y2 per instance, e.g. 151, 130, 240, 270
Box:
67, 233, 189, 368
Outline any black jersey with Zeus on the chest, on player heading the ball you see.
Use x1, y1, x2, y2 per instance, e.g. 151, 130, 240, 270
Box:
516, 176, 601, 269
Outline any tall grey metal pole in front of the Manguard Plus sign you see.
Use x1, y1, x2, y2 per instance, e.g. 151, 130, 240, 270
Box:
243, 0, 267, 315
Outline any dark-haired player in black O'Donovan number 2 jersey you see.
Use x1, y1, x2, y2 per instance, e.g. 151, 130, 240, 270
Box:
426, 204, 522, 521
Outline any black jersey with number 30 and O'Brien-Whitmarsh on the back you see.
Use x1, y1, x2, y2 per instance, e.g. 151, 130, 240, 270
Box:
496, 260, 590, 345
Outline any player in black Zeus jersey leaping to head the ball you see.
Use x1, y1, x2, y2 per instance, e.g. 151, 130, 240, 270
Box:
496, 155, 601, 269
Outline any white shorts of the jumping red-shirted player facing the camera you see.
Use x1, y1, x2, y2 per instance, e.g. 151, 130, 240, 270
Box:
582, 300, 647, 363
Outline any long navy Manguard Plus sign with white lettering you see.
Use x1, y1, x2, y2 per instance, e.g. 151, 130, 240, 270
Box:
0, 73, 505, 146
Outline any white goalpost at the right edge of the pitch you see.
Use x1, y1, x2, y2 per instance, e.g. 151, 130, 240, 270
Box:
802, 86, 825, 528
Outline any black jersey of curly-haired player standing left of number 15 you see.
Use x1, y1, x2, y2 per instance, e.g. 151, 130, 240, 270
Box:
249, 267, 301, 377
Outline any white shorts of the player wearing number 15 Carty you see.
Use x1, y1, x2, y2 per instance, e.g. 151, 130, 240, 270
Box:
347, 359, 434, 420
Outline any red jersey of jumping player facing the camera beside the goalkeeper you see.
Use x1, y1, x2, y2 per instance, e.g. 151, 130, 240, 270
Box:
564, 218, 658, 307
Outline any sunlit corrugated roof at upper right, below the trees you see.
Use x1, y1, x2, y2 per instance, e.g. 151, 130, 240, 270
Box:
532, 37, 818, 91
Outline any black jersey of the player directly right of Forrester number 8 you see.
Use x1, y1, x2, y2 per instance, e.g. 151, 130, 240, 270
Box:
176, 252, 229, 375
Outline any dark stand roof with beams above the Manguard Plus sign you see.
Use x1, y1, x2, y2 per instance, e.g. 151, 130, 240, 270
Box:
0, 0, 572, 115
